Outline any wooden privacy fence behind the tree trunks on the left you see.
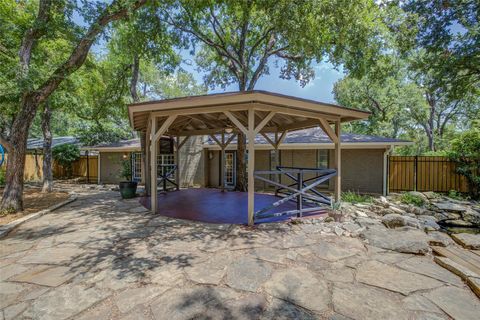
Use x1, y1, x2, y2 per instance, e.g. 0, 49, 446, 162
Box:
4, 154, 98, 182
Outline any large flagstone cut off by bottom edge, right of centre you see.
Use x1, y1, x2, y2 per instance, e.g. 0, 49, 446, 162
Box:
332, 283, 411, 320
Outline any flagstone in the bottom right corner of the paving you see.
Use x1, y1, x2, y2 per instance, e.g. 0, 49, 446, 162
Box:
425, 286, 480, 319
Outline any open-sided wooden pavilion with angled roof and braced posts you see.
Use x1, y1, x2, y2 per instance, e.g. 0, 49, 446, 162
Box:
128, 91, 370, 225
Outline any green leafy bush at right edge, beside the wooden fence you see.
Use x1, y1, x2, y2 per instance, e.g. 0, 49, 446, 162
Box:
449, 123, 480, 199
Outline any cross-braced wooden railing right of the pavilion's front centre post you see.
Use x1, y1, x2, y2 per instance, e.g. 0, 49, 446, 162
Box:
254, 167, 337, 220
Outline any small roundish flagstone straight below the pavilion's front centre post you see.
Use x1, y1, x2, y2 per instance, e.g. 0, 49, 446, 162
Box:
226, 257, 272, 292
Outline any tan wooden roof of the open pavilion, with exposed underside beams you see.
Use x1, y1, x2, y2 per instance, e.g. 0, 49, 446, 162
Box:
128, 90, 370, 136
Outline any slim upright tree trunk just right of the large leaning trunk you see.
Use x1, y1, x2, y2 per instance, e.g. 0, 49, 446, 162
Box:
42, 101, 53, 193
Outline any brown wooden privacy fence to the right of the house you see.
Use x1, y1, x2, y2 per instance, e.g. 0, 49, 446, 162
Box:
388, 156, 468, 192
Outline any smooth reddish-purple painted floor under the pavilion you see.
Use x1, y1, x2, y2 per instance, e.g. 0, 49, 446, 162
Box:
140, 188, 325, 224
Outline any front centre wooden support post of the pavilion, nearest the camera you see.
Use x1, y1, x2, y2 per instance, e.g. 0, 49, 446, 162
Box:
247, 109, 255, 226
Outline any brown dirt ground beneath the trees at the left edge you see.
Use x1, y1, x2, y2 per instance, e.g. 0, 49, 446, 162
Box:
0, 188, 68, 225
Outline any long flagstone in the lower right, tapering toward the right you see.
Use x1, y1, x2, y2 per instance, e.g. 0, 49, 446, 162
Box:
356, 261, 443, 295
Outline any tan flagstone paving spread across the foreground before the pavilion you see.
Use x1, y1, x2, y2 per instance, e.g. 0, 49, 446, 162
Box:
0, 190, 480, 320
